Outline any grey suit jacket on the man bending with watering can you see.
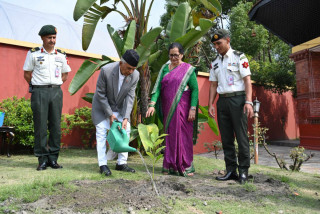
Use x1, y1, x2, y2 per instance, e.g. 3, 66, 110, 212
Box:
91, 62, 139, 125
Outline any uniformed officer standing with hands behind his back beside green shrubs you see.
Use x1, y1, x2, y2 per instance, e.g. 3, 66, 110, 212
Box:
23, 25, 71, 171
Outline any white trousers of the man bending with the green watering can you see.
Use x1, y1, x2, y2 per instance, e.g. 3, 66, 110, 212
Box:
96, 112, 131, 166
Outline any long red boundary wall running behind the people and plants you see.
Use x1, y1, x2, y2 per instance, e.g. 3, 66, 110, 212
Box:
0, 43, 299, 153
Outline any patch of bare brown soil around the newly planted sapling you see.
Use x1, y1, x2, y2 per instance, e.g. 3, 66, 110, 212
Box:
3, 171, 292, 214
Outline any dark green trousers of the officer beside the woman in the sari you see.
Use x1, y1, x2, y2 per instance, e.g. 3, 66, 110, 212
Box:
217, 95, 250, 173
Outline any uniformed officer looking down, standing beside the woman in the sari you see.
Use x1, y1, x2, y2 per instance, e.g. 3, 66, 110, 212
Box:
209, 29, 253, 184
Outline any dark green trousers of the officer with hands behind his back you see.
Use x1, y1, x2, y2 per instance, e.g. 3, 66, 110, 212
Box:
31, 87, 63, 164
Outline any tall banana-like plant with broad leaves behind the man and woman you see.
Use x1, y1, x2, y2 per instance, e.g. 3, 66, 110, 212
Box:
69, 0, 221, 131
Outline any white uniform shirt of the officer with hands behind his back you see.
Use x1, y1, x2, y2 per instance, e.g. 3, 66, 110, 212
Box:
23, 47, 71, 85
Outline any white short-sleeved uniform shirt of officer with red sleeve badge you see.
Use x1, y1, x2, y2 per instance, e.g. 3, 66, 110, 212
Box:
209, 47, 251, 94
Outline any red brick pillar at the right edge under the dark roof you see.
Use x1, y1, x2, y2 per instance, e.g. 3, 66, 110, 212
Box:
290, 50, 320, 150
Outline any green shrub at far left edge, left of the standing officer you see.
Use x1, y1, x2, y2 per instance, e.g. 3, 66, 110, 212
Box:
0, 96, 34, 147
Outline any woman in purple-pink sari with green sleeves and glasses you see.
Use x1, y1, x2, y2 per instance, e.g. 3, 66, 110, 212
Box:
146, 43, 199, 176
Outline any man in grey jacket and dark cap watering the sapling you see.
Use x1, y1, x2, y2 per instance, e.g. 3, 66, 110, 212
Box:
91, 50, 139, 176
